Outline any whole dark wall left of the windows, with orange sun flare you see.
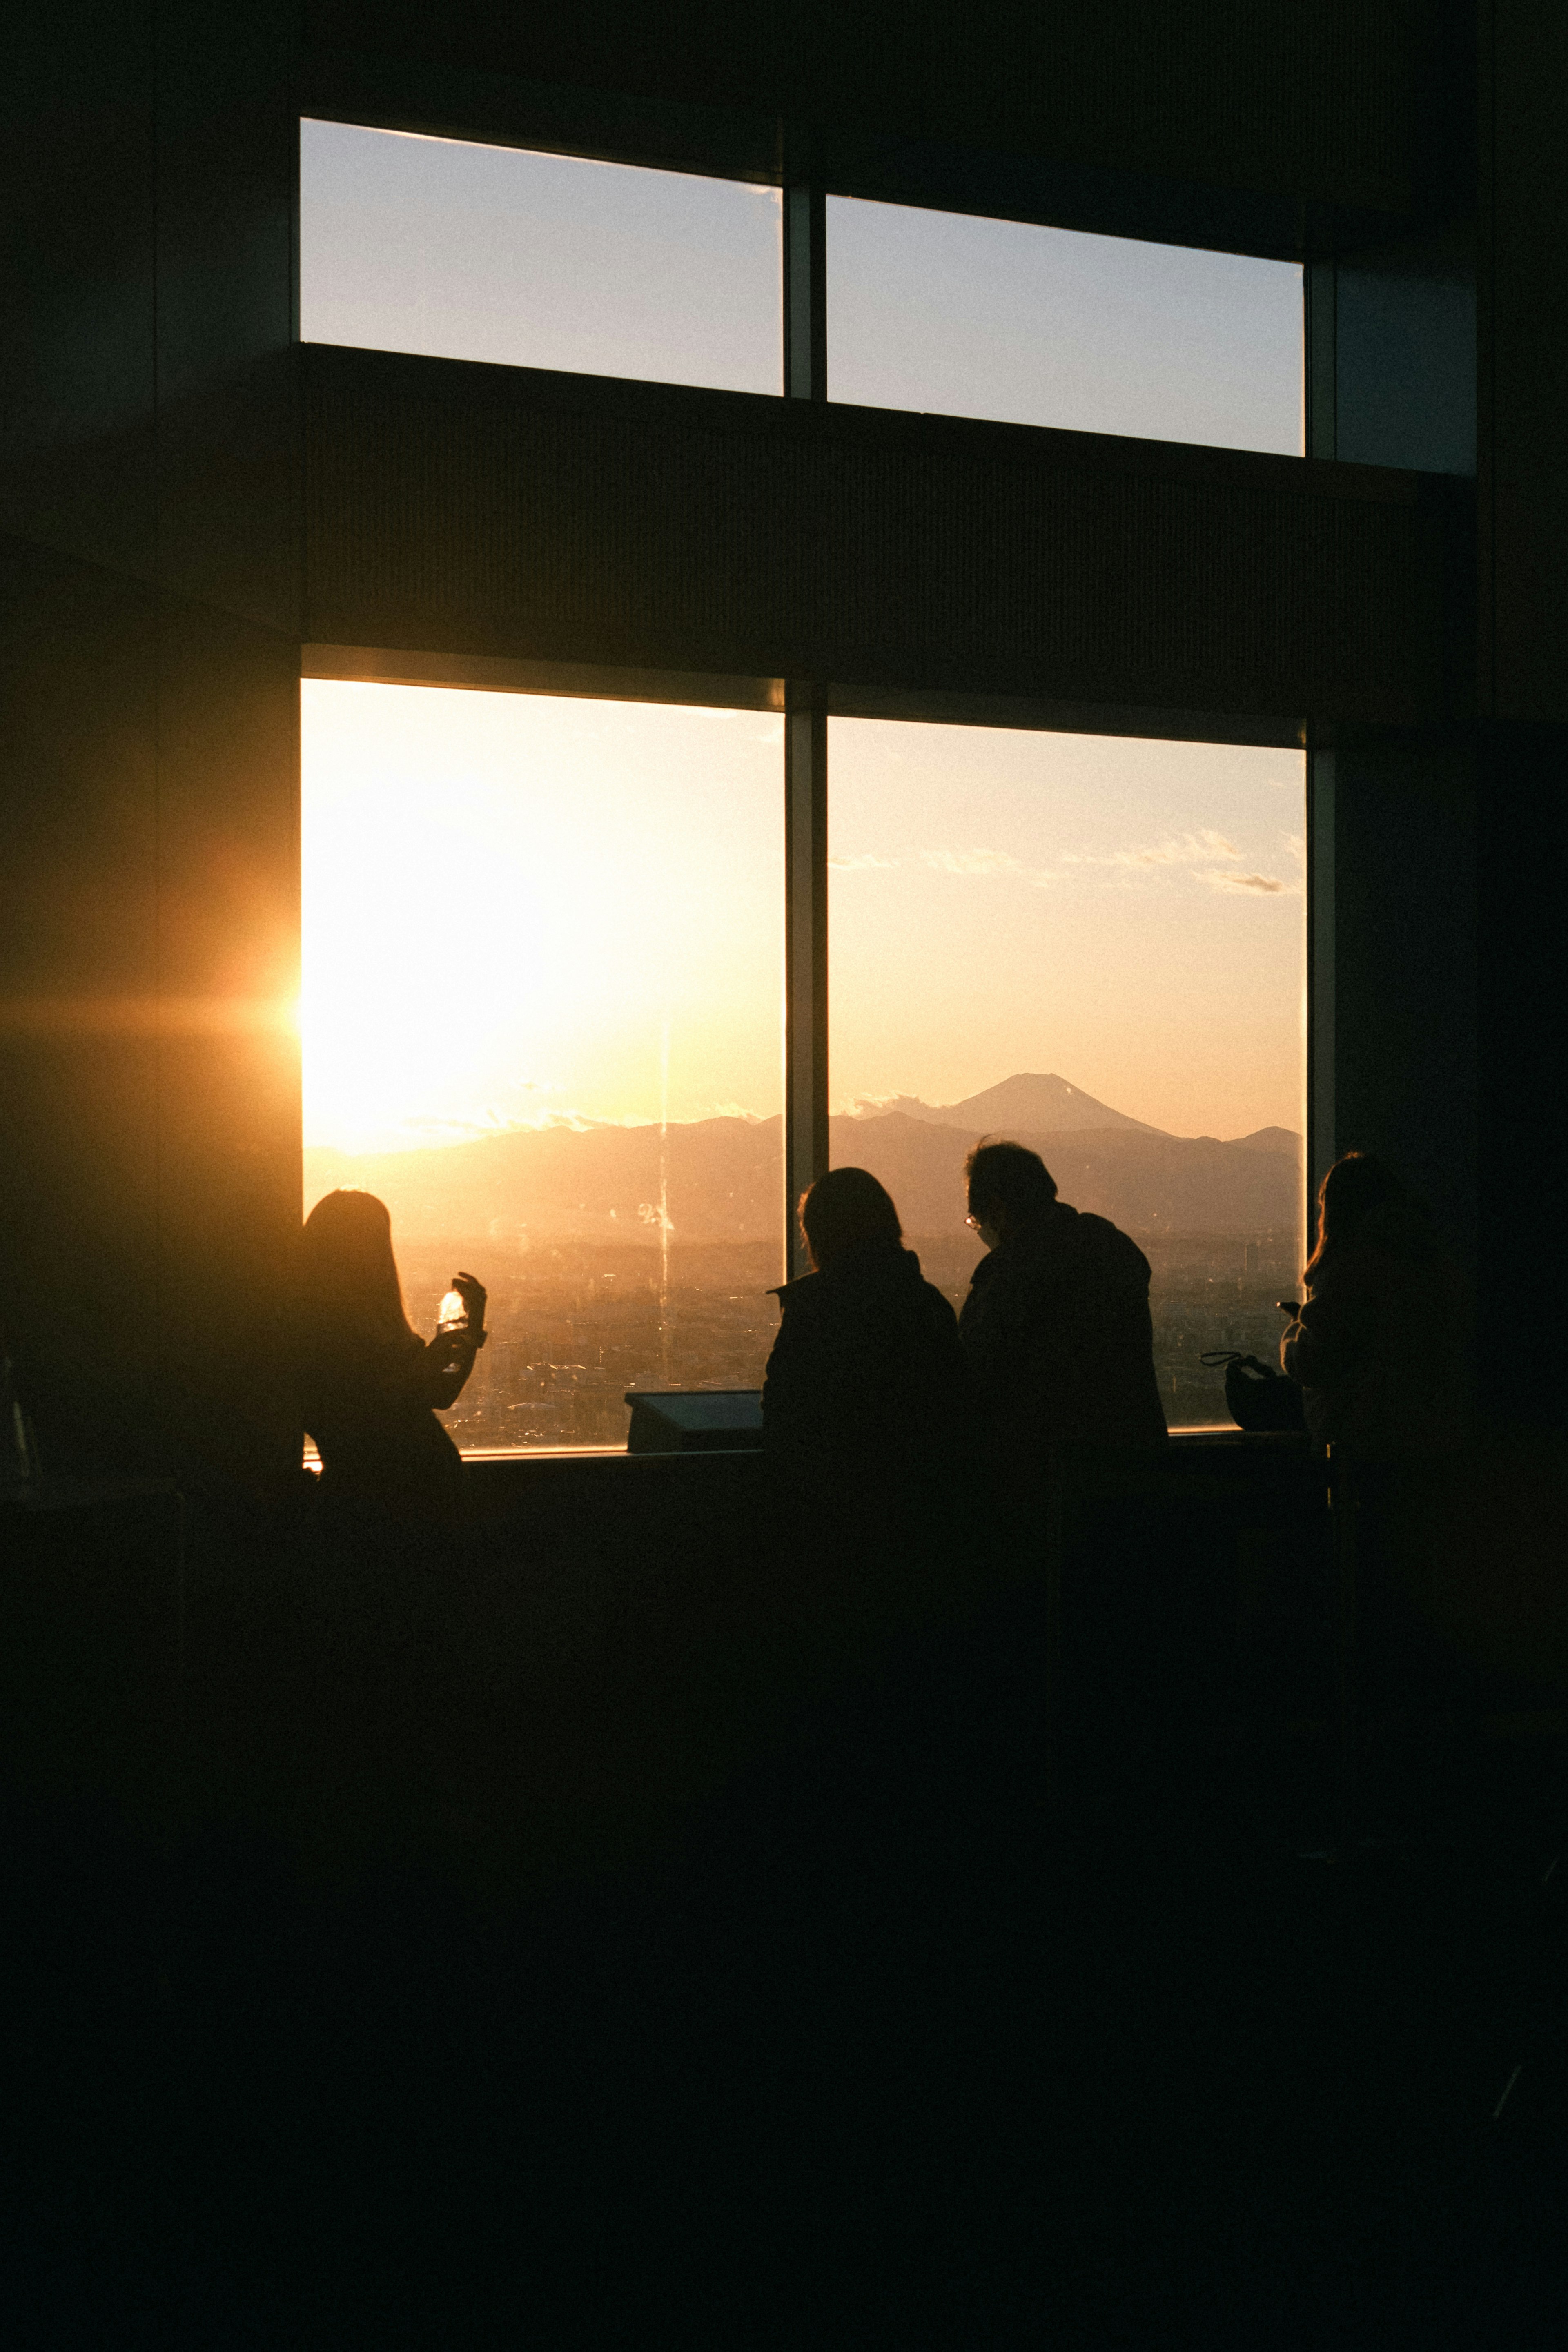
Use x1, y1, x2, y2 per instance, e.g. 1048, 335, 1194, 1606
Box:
0, 0, 298, 1484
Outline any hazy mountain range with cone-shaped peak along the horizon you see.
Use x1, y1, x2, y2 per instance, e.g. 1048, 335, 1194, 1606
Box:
305, 1075, 1300, 1244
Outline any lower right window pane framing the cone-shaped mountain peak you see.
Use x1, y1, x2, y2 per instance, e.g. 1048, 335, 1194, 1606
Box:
828, 720, 1305, 1428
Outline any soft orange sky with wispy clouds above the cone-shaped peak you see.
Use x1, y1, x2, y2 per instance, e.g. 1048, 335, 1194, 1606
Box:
830, 720, 1305, 1136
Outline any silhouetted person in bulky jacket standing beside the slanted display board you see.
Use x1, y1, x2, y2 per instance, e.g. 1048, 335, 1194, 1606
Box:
762, 1169, 969, 1489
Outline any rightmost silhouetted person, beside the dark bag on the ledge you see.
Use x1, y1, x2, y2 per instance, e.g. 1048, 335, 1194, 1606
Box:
1279, 1152, 1469, 1463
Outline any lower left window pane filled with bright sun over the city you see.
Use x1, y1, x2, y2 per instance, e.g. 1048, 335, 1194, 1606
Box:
303, 680, 783, 1449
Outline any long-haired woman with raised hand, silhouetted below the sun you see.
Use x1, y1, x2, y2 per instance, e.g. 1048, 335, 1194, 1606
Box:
301, 1192, 487, 1522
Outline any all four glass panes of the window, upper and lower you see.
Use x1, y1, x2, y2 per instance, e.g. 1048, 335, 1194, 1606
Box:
301, 142, 1305, 1449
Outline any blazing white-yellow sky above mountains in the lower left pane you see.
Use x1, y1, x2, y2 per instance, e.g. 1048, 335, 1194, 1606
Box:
301, 680, 783, 1150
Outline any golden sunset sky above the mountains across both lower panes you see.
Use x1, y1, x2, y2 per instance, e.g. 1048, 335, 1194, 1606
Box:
301, 680, 1305, 1150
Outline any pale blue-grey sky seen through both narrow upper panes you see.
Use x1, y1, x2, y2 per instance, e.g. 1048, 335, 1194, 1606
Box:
301, 120, 1302, 452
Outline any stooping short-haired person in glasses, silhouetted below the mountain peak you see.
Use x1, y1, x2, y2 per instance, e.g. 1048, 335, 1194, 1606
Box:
959, 1143, 1166, 1479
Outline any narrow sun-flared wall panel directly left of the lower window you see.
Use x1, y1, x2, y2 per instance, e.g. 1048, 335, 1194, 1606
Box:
158, 593, 301, 1484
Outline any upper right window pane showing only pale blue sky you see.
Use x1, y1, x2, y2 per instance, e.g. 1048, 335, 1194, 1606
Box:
828, 198, 1302, 456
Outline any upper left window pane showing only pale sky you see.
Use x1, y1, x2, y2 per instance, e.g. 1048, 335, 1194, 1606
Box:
298, 120, 783, 393
